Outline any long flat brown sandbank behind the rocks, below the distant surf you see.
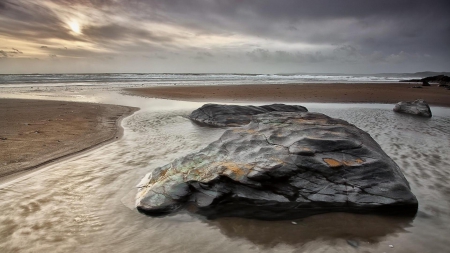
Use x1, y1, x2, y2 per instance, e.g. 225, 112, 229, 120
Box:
125, 83, 450, 107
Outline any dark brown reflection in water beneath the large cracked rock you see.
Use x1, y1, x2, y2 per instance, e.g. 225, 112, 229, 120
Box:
211, 213, 413, 247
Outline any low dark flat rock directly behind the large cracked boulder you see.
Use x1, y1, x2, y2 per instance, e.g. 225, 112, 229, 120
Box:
189, 104, 308, 127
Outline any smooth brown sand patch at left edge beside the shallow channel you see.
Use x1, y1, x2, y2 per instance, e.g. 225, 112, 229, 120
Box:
0, 99, 137, 181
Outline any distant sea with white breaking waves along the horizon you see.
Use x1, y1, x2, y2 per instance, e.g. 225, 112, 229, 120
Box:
0, 73, 425, 88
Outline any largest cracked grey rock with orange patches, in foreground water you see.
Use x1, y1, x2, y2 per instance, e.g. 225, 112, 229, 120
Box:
137, 112, 418, 220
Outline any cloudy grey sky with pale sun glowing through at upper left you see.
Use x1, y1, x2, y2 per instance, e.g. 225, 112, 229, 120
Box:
0, 0, 450, 74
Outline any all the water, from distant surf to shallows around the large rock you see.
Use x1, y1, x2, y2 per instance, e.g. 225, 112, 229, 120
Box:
0, 74, 450, 253
